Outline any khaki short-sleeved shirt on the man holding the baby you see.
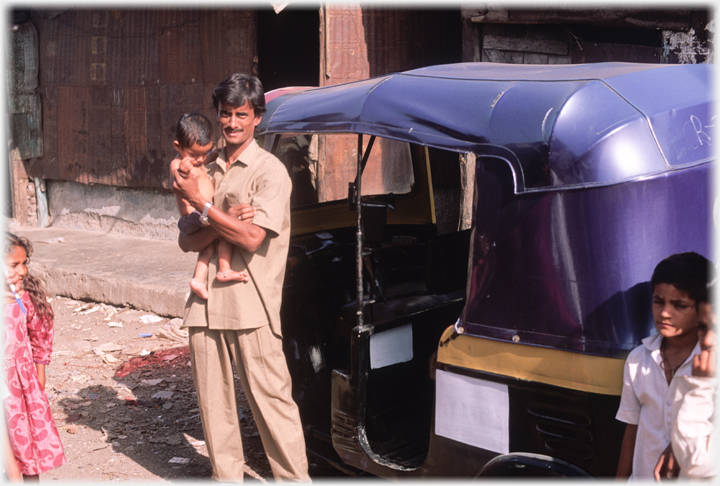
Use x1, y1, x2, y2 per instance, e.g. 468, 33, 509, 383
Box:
183, 140, 292, 336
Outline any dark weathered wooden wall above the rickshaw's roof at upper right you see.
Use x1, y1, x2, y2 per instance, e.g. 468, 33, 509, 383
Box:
463, 7, 711, 64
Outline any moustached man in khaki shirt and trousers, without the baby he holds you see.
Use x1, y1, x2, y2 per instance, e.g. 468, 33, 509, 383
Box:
174, 74, 310, 481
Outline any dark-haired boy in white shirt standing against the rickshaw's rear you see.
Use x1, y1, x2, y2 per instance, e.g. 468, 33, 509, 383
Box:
615, 252, 710, 480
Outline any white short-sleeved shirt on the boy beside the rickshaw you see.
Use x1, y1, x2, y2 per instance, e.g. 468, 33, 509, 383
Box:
615, 334, 700, 480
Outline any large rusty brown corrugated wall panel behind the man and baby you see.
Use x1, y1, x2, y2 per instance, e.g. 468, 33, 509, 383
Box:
28, 8, 256, 189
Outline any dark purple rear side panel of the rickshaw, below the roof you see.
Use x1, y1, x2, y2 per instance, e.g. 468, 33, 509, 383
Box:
461, 159, 710, 356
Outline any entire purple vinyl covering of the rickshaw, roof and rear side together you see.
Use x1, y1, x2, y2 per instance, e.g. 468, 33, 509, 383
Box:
258, 63, 713, 356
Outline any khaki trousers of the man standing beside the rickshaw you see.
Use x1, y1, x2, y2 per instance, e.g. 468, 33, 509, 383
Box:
188, 325, 310, 482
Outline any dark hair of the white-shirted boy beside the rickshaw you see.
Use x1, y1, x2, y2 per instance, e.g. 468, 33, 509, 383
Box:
650, 251, 713, 304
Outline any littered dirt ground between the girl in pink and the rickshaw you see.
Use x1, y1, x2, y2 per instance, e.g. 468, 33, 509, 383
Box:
40, 297, 343, 482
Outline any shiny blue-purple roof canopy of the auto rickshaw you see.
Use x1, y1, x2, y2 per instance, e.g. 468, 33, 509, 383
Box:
256, 63, 712, 193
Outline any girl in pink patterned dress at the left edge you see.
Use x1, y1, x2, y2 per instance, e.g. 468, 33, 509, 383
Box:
3, 233, 65, 480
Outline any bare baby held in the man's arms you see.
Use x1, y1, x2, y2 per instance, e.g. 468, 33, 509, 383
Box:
170, 113, 249, 299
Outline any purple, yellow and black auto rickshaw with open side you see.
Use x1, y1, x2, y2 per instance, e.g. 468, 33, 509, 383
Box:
256, 63, 714, 478
